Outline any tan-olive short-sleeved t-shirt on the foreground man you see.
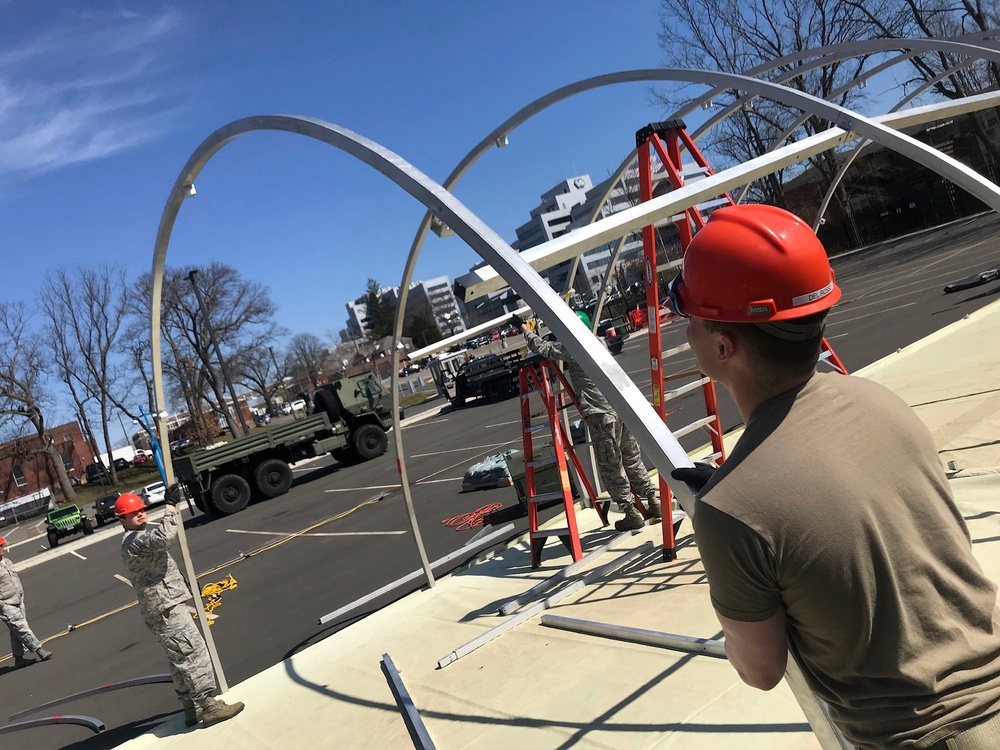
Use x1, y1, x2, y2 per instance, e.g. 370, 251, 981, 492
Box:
693, 374, 1000, 748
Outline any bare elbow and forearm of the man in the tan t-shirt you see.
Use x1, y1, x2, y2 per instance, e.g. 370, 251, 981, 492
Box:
715, 609, 788, 690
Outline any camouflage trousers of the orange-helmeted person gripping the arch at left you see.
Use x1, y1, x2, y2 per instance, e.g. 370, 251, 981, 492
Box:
146, 604, 215, 702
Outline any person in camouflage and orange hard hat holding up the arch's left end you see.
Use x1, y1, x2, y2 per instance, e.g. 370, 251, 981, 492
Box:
115, 483, 243, 727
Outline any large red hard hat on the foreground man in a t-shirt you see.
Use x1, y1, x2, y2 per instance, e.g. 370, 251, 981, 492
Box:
674, 205, 840, 323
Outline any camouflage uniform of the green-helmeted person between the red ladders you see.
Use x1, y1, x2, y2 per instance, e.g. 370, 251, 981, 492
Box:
524, 329, 658, 509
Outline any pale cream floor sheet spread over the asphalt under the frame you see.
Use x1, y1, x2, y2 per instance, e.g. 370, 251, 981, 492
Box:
127, 303, 1000, 750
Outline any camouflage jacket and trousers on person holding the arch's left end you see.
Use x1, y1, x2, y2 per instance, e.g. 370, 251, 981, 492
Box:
122, 510, 215, 705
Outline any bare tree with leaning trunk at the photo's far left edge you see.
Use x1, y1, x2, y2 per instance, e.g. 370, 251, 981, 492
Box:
0, 302, 76, 502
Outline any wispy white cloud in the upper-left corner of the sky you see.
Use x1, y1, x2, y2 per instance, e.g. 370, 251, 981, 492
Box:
0, 10, 180, 178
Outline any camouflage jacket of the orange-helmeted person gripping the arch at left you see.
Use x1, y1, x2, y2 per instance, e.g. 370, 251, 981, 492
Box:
122, 510, 191, 621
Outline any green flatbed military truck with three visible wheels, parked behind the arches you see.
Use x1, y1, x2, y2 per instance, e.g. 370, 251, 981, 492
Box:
174, 373, 392, 515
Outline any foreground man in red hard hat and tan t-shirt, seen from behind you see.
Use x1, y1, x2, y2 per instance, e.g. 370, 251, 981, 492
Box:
668, 205, 1000, 750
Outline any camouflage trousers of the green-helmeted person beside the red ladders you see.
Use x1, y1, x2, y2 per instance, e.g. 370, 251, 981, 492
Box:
587, 414, 657, 508
